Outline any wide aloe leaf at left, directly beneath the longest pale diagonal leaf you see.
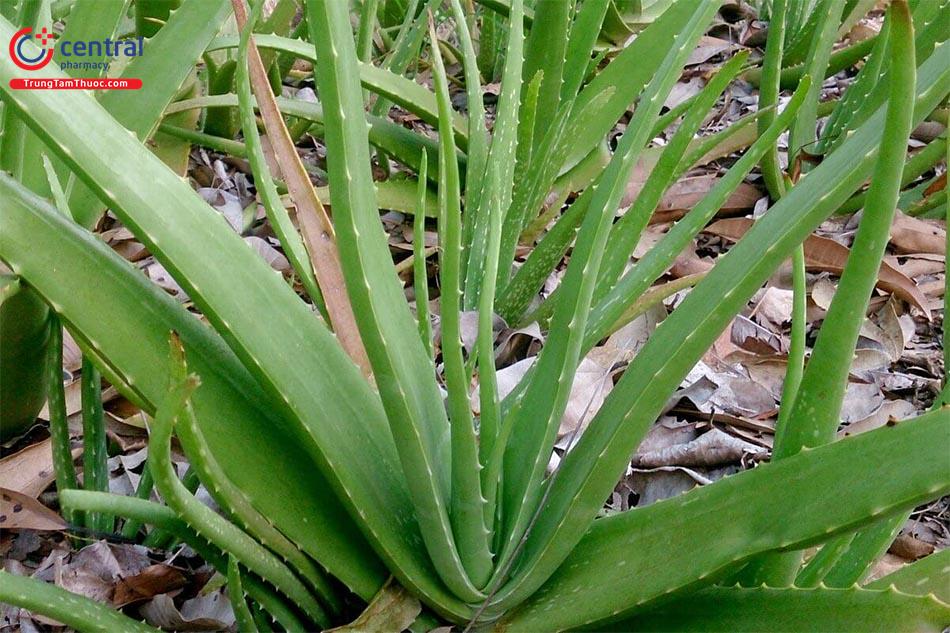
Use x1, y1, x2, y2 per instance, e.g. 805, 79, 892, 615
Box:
0, 175, 386, 599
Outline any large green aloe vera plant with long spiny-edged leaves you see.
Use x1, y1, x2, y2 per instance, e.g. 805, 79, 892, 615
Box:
0, 0, 950, 631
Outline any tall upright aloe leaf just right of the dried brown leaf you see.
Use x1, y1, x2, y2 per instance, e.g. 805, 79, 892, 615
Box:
307, 0, 483, 601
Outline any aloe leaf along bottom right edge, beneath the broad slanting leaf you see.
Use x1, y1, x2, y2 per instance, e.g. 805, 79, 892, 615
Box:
611, 587, 950, 633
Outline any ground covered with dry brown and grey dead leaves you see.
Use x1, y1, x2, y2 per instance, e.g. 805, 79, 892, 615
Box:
0, 5, 950, 633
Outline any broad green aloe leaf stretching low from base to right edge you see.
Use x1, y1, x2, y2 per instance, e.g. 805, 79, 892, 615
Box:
506, 408, 950, 630
